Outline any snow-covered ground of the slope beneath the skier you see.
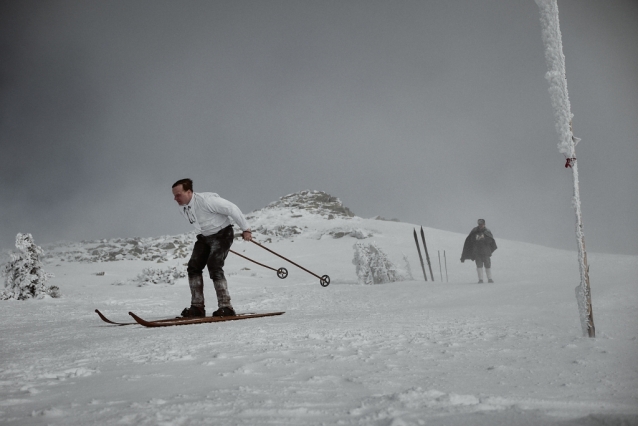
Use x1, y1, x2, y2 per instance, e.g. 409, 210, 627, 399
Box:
0, 192, 638, 425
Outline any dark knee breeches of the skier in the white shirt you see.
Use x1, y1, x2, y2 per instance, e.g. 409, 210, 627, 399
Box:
187, 225, 234, 281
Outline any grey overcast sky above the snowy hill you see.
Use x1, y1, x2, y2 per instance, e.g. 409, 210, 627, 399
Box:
0, 0, 638, 255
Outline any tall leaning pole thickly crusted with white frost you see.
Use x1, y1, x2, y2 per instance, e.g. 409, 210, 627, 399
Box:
535, 0, 596, 337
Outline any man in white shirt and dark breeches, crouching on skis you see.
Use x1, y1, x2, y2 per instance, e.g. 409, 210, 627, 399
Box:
173, 179, 252, 317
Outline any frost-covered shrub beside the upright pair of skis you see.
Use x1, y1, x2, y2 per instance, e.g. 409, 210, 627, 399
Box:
352, 242, 404, 284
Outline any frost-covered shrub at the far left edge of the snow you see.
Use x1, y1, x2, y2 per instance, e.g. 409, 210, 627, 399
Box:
0, 234, 60, 300
